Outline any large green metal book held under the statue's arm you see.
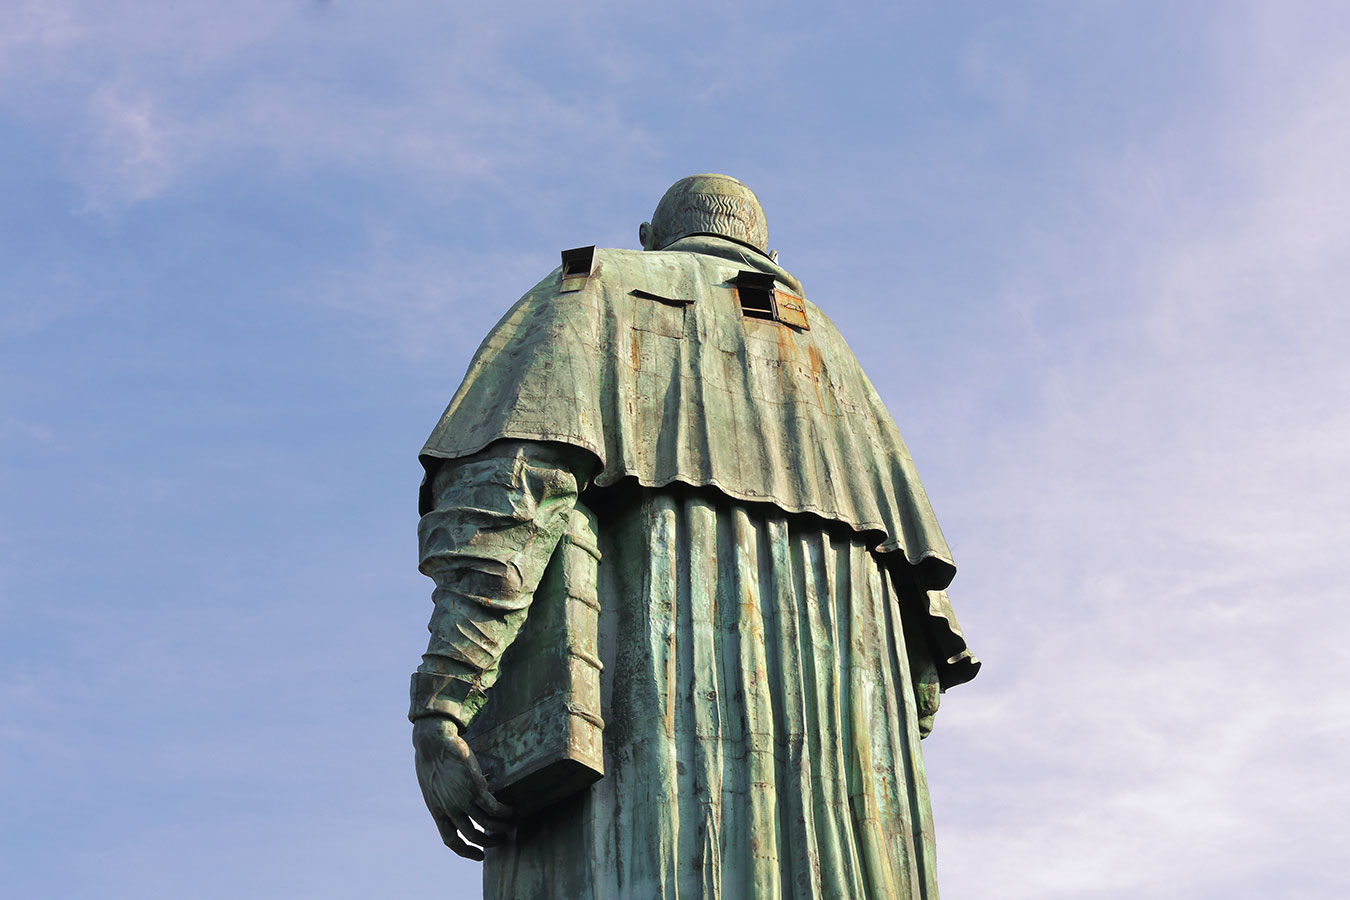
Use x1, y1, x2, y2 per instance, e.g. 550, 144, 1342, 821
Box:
464, 505, 605, 814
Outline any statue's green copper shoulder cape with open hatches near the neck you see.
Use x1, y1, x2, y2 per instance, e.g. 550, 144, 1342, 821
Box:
421, 237, 979, 687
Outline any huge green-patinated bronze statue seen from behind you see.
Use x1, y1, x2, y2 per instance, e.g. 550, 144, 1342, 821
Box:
409, 175, 979, 900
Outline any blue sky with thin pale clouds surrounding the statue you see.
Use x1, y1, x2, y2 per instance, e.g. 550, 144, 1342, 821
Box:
0, 0, 1350, 900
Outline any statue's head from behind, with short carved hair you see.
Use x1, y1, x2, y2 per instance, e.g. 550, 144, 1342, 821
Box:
637, 174, 768, 256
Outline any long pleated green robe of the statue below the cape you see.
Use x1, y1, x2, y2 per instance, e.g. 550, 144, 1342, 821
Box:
485, 490, 938, 900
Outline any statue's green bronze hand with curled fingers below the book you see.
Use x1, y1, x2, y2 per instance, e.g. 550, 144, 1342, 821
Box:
413, 715, 514, 860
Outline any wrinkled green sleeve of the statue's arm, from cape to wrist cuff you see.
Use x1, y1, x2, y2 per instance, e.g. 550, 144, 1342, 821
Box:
408, 441, 590, 727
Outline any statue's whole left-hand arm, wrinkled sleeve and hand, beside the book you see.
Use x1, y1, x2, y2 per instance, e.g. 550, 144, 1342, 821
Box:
408, 441, 590, 860
